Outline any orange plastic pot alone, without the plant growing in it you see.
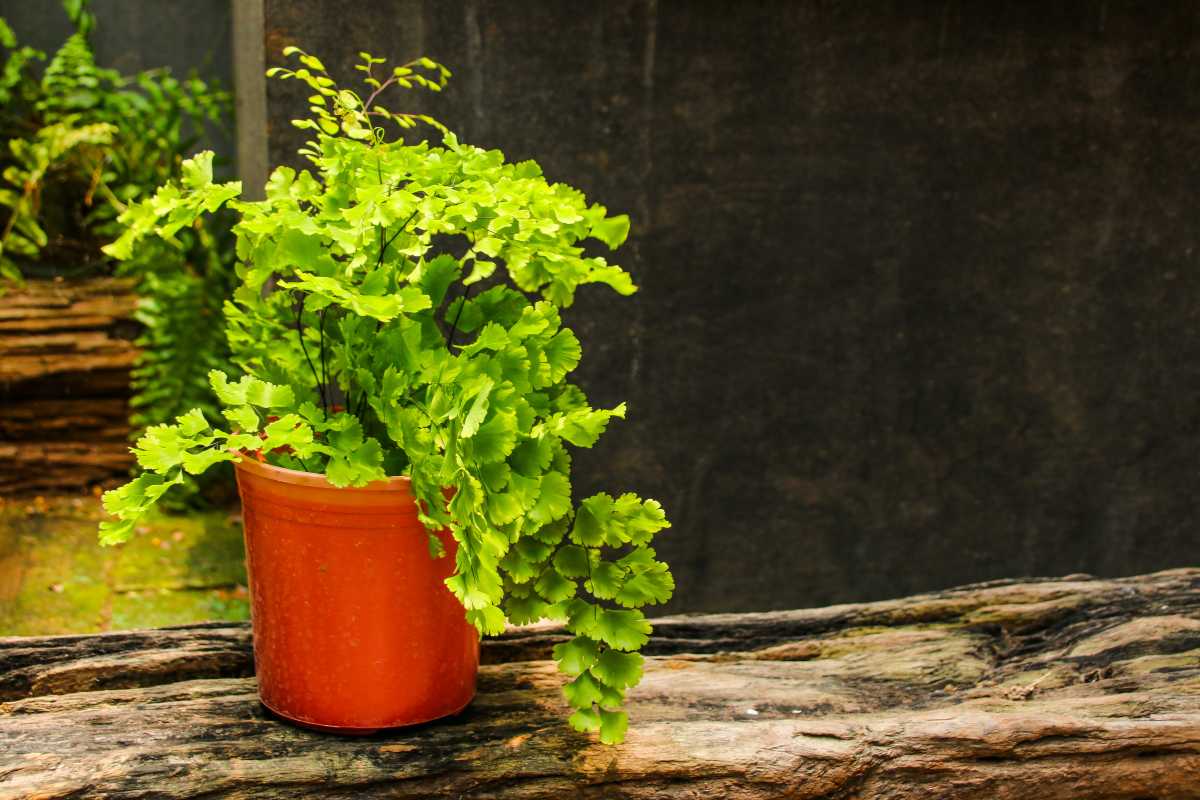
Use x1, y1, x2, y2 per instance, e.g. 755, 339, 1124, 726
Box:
236, 458, 479, 734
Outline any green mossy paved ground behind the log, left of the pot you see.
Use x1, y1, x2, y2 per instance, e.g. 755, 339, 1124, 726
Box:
0, 497, 250, 636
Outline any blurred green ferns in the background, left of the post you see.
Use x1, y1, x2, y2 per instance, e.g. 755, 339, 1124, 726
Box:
0, 0, 235, 501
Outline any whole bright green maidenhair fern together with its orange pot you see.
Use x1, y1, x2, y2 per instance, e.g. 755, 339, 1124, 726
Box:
101, 48, 674, 742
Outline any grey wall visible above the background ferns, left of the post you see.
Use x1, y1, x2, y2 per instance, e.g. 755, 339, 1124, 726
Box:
0, 0, 234, 163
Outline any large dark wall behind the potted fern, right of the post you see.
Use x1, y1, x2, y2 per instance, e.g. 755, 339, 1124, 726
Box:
266, 0, 1200, 610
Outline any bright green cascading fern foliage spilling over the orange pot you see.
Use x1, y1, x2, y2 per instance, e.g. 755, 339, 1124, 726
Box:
101, 48, 674, 744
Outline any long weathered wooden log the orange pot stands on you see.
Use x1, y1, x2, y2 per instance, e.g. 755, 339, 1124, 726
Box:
0, 570, 1200, 800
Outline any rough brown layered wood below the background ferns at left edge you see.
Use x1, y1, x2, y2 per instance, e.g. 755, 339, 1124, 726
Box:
0, 278, 137, 494
